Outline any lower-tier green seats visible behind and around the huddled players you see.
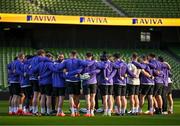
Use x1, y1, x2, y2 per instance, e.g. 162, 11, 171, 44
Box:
0, 47, 180, 89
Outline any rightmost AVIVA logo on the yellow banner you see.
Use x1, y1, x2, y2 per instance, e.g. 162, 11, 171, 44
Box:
132, 18, 163, 25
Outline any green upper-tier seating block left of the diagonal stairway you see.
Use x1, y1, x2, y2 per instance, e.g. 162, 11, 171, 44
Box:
0, 0, 118, 17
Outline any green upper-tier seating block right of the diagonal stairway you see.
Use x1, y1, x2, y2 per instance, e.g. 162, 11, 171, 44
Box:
110, 0, 180, 18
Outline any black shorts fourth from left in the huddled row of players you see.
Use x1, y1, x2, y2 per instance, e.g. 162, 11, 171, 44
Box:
40, 84, 52, 96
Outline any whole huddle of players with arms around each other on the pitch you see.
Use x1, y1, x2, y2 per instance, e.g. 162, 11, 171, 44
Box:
7, 49, 173, 117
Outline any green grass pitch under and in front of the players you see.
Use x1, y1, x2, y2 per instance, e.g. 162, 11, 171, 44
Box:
0, 99, 180, 126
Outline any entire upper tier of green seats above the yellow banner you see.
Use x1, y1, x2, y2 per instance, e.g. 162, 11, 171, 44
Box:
0, 0, 180, 18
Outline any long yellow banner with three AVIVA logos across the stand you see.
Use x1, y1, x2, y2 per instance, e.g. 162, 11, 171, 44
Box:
0, 13, 180, 27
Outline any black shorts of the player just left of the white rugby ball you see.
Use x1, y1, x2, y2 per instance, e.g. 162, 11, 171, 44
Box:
66, 82, 81, 95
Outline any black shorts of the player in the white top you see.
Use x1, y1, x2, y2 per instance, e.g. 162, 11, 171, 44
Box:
127, 84, 140, 96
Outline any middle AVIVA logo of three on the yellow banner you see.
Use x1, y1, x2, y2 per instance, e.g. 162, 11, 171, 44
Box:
80, 17, 108, 24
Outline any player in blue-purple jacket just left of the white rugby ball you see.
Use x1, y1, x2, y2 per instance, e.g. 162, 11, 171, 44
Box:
60, 50, 88, 117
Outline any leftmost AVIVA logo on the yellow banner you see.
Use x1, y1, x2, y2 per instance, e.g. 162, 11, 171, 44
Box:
27, 15, 56, 22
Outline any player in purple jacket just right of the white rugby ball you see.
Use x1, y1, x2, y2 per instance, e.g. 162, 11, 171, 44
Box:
82, 52, 100, 117
